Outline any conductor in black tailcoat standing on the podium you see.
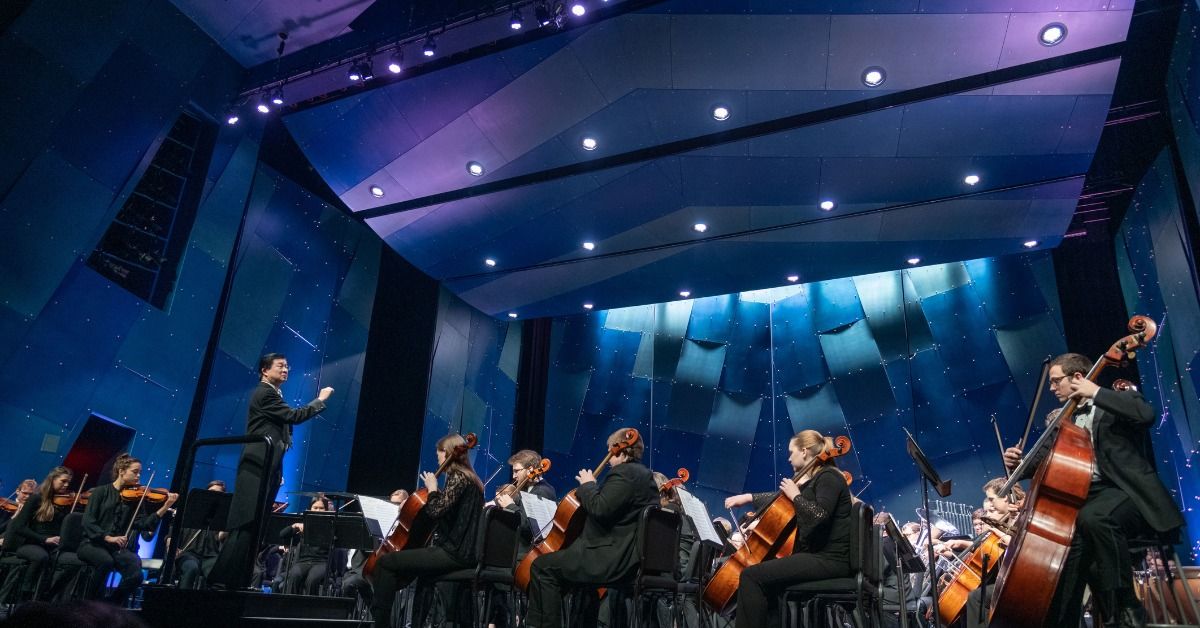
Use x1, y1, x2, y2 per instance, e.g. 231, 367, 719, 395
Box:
209, 353, 334, 588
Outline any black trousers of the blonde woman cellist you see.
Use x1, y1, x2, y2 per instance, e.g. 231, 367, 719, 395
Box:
736, 554, 850, 628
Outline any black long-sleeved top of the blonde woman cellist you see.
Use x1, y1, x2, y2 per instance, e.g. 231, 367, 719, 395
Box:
754, 466, 851, 561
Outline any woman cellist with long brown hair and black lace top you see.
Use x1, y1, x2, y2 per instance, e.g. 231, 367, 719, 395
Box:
372, 433, 484, 628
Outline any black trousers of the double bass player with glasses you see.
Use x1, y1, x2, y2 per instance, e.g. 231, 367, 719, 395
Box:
1046, 479, 1150, 626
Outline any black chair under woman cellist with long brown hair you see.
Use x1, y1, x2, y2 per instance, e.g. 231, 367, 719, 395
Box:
432, 506, 521, 628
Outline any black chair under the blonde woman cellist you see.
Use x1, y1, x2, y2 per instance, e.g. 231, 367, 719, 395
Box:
779, 502, 881, 628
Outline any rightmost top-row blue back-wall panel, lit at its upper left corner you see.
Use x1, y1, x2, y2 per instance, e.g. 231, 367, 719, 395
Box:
962, 256, 1049, 325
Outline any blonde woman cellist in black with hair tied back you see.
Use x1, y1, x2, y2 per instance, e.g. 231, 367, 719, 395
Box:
725, 430, 851, 628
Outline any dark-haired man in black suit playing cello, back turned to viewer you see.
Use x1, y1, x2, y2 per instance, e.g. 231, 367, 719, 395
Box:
526, 427, 659, 628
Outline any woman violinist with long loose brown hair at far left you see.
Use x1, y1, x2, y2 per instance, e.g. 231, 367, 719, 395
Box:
0, 467, 72, 600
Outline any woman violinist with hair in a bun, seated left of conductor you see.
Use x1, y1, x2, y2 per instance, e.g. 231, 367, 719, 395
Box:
77, 454, 179, 606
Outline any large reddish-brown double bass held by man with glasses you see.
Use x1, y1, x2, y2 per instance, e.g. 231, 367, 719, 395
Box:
990, 315, 1158, 628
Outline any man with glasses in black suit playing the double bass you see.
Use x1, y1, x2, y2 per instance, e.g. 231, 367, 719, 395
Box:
1004, 353, 1183, 626
